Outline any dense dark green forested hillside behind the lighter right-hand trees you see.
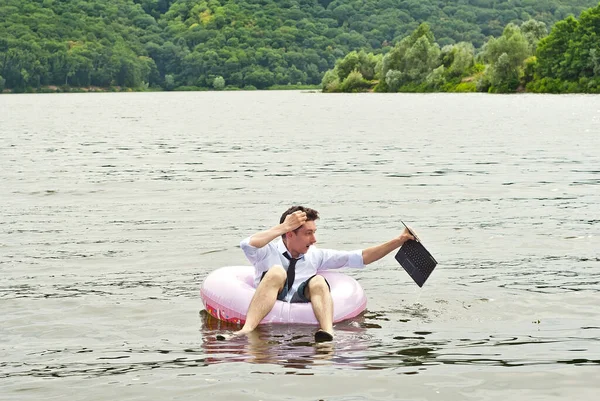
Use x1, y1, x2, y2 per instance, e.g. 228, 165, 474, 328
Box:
0, 0, 598, 91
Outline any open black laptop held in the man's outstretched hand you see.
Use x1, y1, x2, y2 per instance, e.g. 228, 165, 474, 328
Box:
396, 221, 437, 287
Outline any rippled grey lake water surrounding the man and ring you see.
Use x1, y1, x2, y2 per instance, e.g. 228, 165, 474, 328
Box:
0, 91, 600, 401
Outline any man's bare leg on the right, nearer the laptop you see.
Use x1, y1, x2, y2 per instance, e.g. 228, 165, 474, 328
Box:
305, 275, 333, 341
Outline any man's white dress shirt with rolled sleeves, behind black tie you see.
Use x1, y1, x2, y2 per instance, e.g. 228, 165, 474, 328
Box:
240, 237, 365, 301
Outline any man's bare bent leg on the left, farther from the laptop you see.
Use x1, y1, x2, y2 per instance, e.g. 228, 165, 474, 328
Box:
217, 266, 287, 340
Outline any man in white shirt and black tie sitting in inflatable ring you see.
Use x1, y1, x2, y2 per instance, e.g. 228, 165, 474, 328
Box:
217, 206, 414, 342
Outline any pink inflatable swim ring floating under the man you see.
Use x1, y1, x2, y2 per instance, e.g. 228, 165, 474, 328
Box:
200, 266, 367, 324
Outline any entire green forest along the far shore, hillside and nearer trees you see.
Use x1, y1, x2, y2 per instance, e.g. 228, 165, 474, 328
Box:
0, 0, 600, 92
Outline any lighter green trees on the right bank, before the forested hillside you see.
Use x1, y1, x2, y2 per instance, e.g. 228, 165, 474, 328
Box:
322, 4, 600, 93
